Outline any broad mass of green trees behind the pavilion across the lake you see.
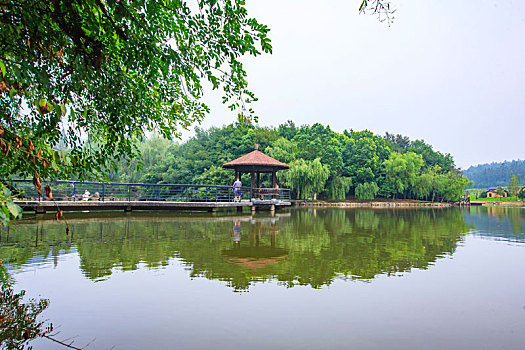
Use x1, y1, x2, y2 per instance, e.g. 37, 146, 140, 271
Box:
109, 121, 469, 201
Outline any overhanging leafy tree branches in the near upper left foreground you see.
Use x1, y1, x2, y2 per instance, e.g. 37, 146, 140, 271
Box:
0, 0, 272, 182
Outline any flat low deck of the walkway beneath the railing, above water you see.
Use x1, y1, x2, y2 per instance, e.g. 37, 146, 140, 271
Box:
15, 200, 291, 213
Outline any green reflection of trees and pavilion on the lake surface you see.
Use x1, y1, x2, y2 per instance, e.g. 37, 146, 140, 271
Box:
0, 209, 471, 291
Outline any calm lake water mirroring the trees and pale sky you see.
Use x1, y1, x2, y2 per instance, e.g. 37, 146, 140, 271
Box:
0, 207, 525, 349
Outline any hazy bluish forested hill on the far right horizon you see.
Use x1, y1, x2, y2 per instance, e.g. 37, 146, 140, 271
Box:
463, 160, 525, 188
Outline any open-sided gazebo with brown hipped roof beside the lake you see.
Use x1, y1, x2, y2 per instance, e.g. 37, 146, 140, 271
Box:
222, 144, 290, 188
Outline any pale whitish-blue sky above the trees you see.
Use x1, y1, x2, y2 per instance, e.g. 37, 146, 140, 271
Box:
184, 0, 525, 169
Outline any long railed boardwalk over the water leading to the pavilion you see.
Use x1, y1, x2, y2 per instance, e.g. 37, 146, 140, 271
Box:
13, 180, 291, 213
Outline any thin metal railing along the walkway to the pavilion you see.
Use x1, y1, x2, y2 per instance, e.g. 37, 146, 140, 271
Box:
9, 180, 291, 202
